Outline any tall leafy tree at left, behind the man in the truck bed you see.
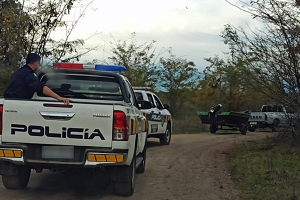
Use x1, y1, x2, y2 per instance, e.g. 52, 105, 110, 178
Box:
0, 0, 98, 94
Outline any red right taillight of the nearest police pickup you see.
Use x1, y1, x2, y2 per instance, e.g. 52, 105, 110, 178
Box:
113, 111, 128, 141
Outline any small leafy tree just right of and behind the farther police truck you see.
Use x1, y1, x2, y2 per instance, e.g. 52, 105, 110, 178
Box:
157, 54, 200, 118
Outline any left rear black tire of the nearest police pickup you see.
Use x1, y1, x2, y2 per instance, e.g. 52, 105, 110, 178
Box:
2, 166, 31, 190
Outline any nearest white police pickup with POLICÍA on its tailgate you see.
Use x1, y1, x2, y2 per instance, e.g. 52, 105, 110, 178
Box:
0, 63, 151, 196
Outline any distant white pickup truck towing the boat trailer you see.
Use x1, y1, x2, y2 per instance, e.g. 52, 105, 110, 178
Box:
248, 105, 291, 132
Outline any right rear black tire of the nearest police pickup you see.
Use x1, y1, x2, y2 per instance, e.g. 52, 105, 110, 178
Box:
113, 148, 136, 197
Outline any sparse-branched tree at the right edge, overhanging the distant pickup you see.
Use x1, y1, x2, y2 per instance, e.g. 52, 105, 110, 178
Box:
222, 0, 300, 142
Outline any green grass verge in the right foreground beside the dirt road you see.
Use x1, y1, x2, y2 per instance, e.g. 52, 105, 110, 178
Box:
230, 138, 300, 200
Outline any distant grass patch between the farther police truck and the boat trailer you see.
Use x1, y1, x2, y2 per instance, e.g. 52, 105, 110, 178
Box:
173, 114, 209, 134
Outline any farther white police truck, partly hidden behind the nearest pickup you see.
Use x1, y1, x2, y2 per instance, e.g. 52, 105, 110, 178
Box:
133, 87, 172, 145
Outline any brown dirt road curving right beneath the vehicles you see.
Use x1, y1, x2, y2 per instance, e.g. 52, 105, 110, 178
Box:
0, 132, 270, 200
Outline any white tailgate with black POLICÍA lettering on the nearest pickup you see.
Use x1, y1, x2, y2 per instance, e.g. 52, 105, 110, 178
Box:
2, 100, 113, 147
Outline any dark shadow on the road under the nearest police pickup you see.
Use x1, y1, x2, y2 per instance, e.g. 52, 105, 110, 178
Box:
1, 171, 112, 199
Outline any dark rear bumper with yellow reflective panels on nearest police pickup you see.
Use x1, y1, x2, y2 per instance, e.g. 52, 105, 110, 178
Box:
0, 144, 129, 168
